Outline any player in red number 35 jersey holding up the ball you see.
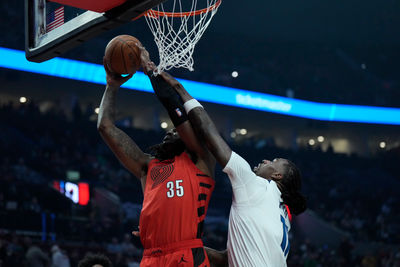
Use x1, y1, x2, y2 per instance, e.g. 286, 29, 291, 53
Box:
97, 49, 215, 267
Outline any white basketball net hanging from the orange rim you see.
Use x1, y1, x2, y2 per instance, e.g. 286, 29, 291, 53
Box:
145, 0, 221, 74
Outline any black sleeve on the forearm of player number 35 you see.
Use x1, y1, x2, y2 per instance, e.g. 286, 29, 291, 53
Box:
149, 74, 188, 127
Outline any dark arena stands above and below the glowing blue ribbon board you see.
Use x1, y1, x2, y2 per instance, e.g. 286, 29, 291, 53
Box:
0, 0, 400, 266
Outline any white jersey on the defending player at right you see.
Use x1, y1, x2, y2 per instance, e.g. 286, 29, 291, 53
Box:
223, 151, 290, 267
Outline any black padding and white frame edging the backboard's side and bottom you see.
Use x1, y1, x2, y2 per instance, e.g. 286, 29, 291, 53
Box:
25, 0, 164, 62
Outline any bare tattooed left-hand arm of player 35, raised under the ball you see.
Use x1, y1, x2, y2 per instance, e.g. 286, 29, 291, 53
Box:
97, 59, 150, 187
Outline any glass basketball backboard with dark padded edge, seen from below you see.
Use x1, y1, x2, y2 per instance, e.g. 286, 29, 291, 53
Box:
25, 0, 165, 62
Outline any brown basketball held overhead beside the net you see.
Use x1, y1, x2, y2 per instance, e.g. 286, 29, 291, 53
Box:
104, 35, 141, 74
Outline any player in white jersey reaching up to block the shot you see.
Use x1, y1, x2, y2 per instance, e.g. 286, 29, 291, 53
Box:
161, 74, 306, 267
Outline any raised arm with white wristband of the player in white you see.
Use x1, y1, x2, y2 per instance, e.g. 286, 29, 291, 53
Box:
170, 84, 232, 167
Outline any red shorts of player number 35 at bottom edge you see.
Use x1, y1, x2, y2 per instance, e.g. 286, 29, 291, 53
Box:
140, 239, 210, 267
